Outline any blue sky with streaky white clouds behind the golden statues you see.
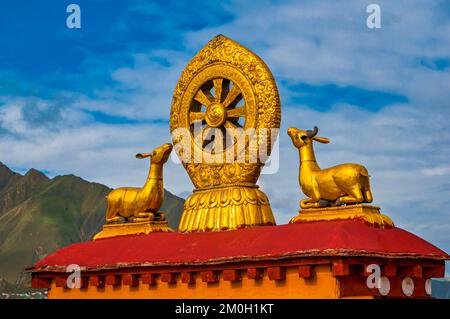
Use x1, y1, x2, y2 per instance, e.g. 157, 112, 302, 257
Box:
0, 0, 450, 274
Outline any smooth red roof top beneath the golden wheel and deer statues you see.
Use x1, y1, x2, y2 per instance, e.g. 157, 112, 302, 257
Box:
30, 220, 450, 270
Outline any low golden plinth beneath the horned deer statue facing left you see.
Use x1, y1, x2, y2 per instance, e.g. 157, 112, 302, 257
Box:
289, 204, 394, 228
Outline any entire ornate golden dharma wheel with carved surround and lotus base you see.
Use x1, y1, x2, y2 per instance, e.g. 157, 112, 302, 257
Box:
170, 35, 281, 231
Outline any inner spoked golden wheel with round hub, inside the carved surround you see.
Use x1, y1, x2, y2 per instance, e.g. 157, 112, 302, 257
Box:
182, 64, 256, 163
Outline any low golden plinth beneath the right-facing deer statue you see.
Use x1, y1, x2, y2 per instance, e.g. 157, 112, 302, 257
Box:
93, 219, 173, 240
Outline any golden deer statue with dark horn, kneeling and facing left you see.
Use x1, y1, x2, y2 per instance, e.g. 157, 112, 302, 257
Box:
288, 126, 373, 209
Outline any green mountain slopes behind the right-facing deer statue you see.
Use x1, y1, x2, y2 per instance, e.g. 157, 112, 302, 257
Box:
0, 162, 184, 290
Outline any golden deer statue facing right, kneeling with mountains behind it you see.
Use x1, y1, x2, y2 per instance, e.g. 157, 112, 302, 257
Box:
106, 144, 172, 223
